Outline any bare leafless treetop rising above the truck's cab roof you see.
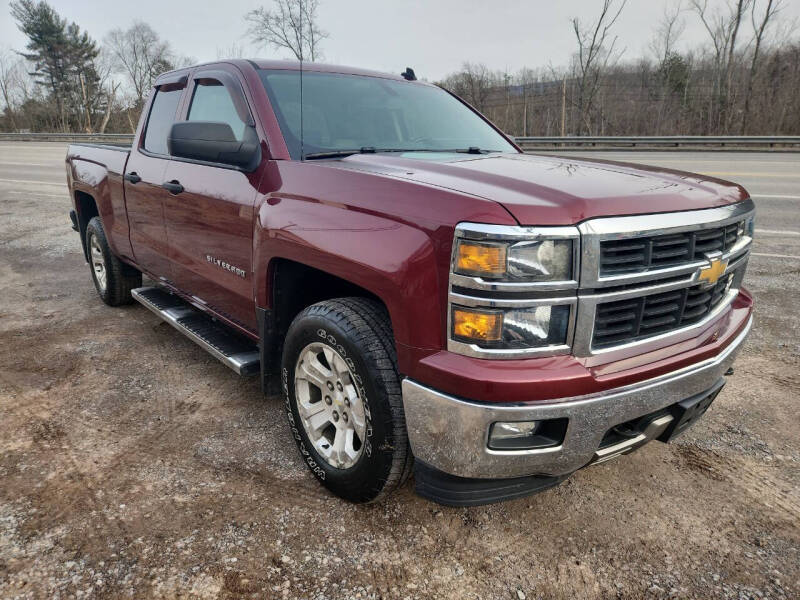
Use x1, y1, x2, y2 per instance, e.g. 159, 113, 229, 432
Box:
244, 0, 328, 61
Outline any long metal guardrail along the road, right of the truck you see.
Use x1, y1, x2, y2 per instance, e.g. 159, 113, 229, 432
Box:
514, 135, 800, 150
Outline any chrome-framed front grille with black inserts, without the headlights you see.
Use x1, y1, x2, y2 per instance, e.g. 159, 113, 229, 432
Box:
572, 199, 755, 357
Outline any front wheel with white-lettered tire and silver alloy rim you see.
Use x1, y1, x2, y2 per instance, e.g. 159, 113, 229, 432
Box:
281, 298, 413, 502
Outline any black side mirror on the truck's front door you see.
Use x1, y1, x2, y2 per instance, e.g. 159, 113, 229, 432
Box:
167, 121, 261, 170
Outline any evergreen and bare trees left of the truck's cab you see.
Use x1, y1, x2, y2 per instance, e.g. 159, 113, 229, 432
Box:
0, 0, 193, 133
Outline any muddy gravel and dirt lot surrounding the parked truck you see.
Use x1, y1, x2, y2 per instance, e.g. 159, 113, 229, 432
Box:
0, 144, 800, 600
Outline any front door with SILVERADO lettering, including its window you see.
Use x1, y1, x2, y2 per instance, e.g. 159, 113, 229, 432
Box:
164, 65, 262, 332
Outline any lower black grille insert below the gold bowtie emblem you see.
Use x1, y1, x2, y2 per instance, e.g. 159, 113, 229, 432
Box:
592, 272, 734, 348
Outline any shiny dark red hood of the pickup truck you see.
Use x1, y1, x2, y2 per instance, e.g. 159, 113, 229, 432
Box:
320, 152, 747, 225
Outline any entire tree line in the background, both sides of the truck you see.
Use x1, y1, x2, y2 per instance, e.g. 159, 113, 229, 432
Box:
0, 0, 800, 136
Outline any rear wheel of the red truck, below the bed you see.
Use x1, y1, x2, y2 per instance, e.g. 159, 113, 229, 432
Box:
86, 217, 142, 306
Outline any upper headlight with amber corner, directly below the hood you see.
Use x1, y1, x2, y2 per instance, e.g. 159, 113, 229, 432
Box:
455, 239, 573, 281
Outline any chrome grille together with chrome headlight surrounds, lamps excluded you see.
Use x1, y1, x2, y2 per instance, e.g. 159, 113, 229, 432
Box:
447, 199, 755, 360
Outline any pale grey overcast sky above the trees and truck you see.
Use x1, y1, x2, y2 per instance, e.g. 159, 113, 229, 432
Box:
0, 0, 800, 80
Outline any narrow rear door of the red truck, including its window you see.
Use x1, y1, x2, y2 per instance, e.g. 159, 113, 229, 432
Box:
125, 75, 187, 281
